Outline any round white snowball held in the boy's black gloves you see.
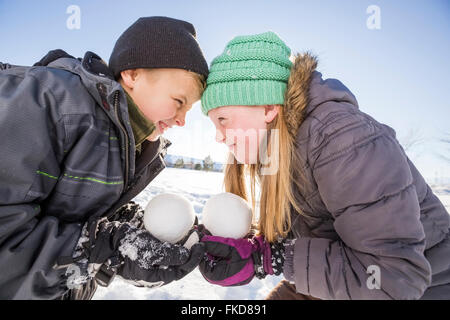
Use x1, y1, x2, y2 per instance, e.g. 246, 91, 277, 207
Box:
144, 193, 195, 243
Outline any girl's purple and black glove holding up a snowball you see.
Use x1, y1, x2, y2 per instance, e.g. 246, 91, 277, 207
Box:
199, 235, 285, 287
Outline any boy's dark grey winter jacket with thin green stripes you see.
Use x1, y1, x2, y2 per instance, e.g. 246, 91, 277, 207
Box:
0, 52, 170, 299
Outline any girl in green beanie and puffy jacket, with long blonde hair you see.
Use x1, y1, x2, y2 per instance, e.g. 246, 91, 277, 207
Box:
200, 32, 450, 299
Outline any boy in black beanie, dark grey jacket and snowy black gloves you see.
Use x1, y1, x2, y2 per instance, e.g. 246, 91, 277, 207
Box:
0, 17, 208, 299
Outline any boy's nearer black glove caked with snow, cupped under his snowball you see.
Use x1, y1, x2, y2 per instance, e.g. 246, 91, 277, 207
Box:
86, 219, 204, 287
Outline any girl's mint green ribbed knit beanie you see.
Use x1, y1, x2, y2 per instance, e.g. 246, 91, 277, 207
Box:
201, 31, 292, 115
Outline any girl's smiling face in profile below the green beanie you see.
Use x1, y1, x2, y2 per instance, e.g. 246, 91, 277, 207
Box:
208, 105, 280, 164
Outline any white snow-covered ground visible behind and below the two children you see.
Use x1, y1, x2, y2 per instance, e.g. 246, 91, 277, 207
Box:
94, 168, 450, 300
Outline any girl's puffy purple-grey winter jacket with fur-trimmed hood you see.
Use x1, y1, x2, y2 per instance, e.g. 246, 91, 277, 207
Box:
285, 54, 450, 299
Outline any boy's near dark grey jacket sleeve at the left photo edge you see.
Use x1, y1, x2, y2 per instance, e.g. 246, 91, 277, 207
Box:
0, 69, 81, 299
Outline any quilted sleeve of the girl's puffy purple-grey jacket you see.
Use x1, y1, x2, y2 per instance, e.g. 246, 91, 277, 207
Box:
293, 114, 431, 299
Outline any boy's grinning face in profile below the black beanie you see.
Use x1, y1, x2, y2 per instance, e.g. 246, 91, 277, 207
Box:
119, 68, 201, 141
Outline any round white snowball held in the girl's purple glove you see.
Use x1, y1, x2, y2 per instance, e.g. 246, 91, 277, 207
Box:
202, 192, 252, 239
